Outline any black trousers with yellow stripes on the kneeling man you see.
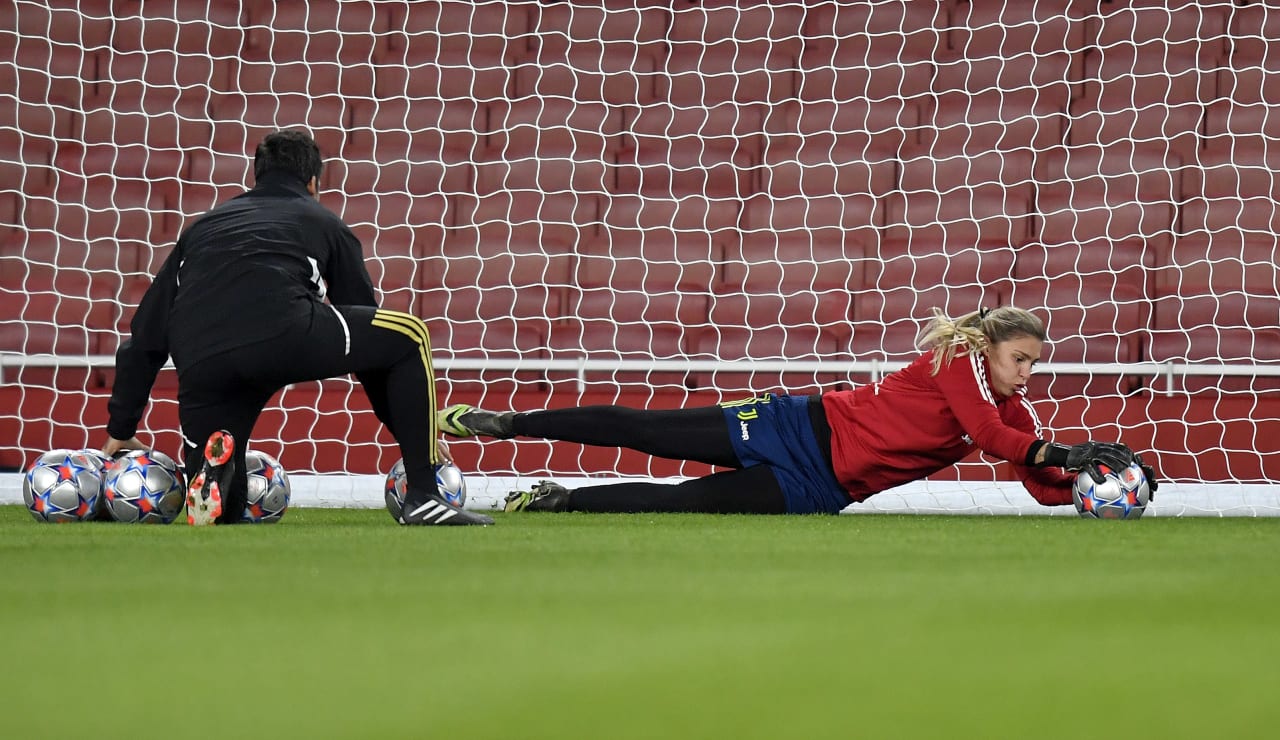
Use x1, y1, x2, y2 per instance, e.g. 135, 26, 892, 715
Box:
175, 305, 438, 524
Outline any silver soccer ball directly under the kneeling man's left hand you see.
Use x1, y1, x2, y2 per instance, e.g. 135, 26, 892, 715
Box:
102, 449, 187, 524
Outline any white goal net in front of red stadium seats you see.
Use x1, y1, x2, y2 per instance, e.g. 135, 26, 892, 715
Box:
0, 0, 1280, 513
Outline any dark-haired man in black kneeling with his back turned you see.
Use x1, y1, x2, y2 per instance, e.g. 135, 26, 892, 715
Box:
102, 131, 493, 525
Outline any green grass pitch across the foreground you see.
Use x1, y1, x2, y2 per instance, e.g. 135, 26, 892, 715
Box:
0, 506, 1280, 739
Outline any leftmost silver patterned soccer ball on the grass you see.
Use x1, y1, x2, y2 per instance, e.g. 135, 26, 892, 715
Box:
22, 449, 106, 522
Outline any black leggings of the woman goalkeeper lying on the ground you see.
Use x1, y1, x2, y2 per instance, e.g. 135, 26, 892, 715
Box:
515, 406, 787, 513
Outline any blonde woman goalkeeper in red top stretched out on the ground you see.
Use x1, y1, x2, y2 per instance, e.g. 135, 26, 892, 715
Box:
439, 306, 1157, 513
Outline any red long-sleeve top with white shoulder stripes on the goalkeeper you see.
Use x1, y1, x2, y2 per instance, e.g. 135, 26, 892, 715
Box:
822, 350, 1074, 506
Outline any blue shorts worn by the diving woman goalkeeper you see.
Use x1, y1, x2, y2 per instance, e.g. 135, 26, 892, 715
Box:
721, 393, 850, 513
